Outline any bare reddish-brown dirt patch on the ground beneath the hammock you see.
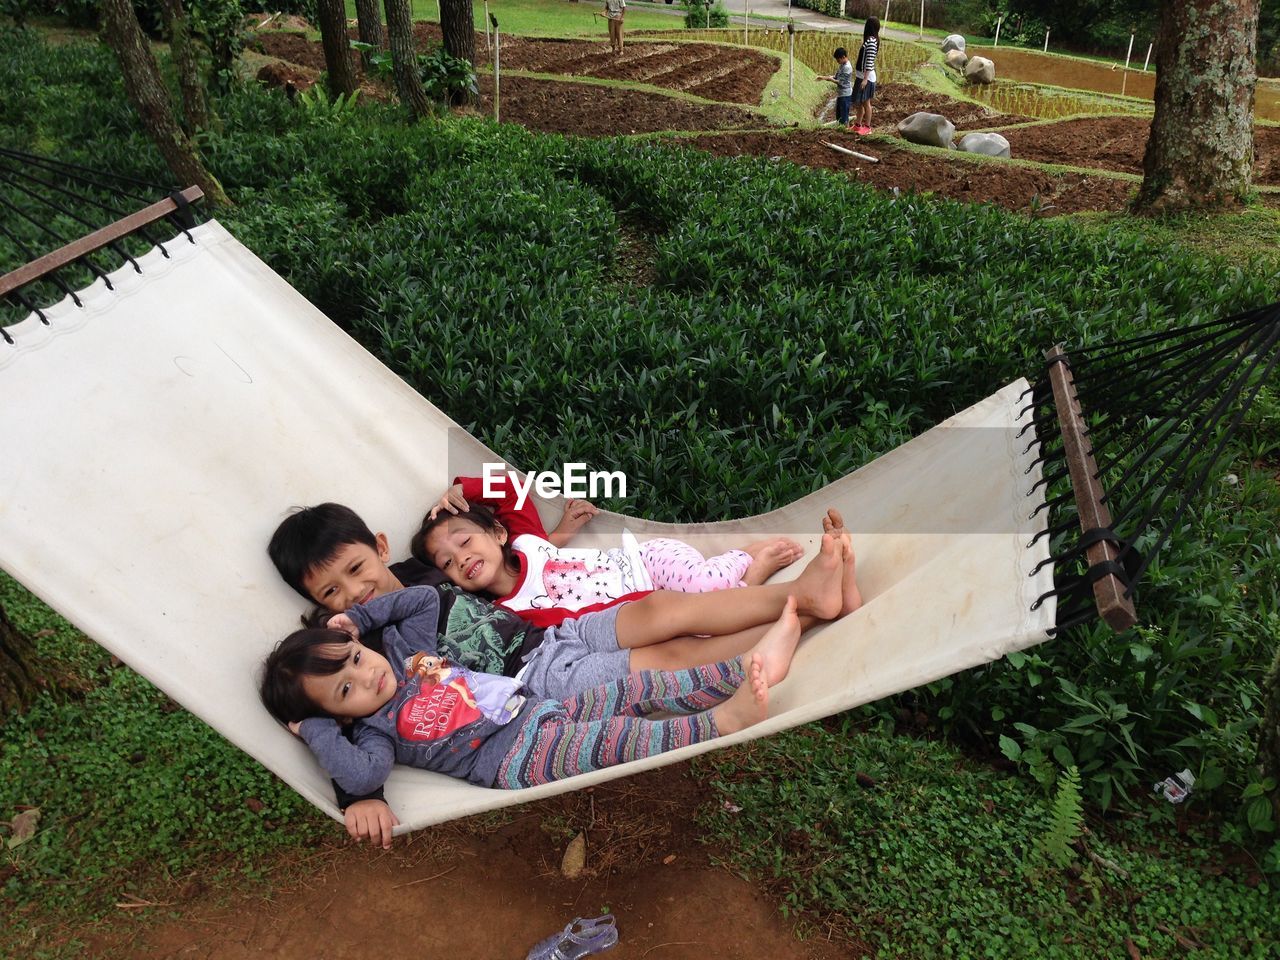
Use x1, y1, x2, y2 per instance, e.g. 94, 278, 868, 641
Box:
81, 764, 864, 960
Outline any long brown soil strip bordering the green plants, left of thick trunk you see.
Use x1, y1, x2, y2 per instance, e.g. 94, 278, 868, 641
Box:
681, 129, 1133, 215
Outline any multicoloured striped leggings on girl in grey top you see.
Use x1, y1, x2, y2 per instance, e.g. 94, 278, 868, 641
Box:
494, 659, 744, 790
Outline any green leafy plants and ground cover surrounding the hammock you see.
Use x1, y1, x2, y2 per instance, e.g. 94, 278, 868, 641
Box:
0, 20, 1280, 957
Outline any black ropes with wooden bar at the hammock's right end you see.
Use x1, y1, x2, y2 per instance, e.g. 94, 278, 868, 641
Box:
1024, 303, 1280, 640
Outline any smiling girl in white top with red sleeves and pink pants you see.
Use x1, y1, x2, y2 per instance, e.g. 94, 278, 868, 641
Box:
411, 477, 804, 626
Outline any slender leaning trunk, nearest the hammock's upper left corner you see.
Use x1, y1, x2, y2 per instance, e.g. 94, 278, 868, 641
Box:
101, 0, 230, 206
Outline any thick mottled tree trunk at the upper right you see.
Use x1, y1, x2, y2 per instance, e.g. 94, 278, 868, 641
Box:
1134, 0, 1260, 214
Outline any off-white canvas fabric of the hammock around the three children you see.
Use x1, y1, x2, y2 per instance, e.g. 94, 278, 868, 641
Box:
0, 223, 1053, 831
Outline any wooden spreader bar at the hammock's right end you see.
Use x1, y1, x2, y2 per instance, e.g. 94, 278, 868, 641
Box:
1044, 344, 1138, 634
